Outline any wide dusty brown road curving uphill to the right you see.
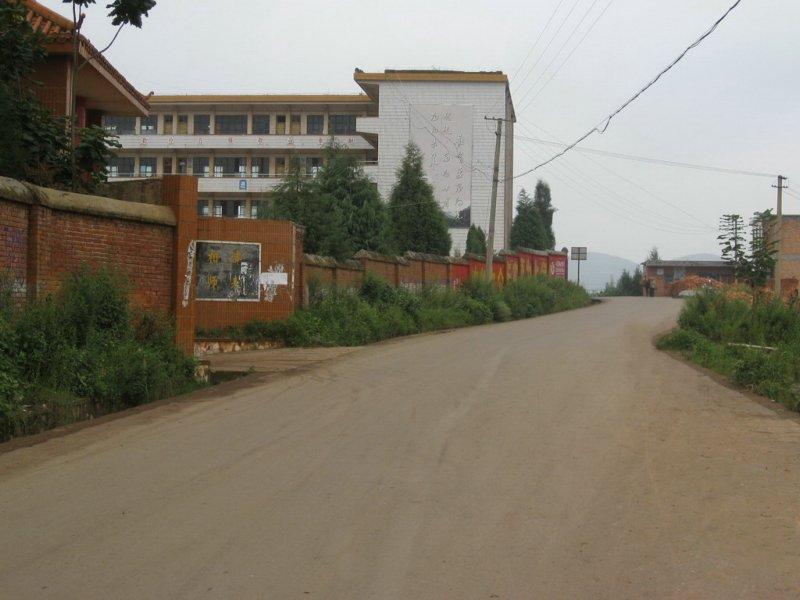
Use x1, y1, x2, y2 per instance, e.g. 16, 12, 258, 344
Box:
0, 299, 800, 599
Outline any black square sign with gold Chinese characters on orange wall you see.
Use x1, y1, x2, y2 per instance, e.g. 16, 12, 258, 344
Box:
195, 241, 261, 302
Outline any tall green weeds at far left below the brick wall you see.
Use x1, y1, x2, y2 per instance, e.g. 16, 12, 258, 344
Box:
0, 268, 200, 440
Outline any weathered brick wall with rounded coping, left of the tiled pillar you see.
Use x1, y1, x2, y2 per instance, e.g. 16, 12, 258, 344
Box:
0, 178, 175, 312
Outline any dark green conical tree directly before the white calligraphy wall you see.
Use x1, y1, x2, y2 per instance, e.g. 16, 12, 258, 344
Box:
389, 143, 452, 255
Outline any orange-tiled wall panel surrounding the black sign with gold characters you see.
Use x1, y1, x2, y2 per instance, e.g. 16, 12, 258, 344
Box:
194, 217, 303, 329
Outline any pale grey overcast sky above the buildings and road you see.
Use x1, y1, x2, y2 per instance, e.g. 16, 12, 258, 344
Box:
43, 0, 800, 260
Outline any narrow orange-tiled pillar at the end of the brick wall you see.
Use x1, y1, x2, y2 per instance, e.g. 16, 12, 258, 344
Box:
163, 175, 198, 354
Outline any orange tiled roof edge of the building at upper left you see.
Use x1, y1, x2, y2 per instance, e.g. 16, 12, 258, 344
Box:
23, 0, 149, 115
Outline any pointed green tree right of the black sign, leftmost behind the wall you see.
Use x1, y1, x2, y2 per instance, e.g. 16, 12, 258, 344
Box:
266, 157, 353, 259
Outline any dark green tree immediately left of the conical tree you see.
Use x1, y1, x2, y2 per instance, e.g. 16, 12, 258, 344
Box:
316, 146, 388, 252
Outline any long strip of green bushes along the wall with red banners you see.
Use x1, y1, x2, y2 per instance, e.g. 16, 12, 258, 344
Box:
200, 275, 590, 346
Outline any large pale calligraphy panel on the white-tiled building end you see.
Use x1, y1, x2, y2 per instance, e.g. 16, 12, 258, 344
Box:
409, 104, 473, 228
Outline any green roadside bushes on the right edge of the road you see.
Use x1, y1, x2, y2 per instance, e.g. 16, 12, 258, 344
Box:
658, 289, 800, 410
